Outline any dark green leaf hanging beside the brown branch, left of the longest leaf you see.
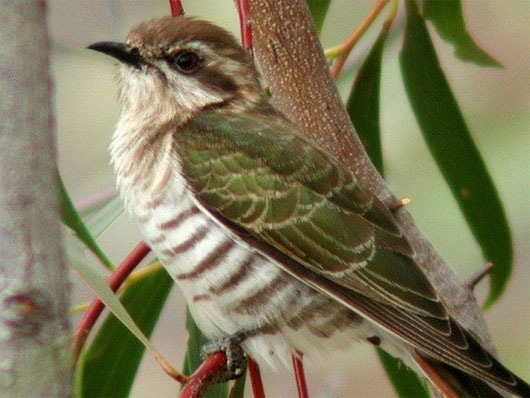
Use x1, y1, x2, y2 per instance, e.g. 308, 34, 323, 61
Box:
346, 28, 388, 174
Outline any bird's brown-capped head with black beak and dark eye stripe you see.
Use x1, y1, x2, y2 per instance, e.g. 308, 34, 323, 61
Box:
89, 16, 264, 117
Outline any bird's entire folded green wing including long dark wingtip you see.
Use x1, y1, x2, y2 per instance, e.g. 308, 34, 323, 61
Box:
175, 111, 514, 388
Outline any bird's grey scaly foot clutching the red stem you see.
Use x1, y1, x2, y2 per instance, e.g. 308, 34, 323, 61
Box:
201, 330, 250, 381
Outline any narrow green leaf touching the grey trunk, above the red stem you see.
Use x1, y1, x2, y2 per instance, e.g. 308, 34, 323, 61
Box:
57, 172, 114, 269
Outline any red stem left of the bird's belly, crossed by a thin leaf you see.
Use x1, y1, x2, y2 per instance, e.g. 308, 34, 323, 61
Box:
74, 242, 151, 359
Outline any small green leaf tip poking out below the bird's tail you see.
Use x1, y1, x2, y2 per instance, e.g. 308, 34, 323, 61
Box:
377, 348, 431, 398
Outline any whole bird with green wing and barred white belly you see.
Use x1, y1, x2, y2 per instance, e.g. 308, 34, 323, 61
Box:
89, 16, 530, 397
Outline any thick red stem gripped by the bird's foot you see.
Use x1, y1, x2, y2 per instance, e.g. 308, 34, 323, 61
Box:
180, 351, 226, 398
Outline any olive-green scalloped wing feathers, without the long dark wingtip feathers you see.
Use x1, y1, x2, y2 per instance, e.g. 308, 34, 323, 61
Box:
176, 112, 438, 317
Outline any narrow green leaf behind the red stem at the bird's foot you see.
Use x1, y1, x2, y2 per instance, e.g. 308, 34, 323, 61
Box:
183, 310, 228, 398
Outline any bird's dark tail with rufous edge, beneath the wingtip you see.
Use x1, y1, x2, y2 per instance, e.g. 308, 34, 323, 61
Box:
413, 354, 530, 398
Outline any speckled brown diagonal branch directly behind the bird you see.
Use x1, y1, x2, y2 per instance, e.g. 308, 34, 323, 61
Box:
249, 0, 493, 352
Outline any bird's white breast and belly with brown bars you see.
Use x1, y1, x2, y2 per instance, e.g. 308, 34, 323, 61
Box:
111, 123, 378, 367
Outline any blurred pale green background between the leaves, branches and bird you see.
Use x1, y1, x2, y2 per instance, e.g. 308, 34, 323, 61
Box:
49, 0, 530, 397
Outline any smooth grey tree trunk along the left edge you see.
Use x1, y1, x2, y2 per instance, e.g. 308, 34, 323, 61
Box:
0, 0, 72, 397
